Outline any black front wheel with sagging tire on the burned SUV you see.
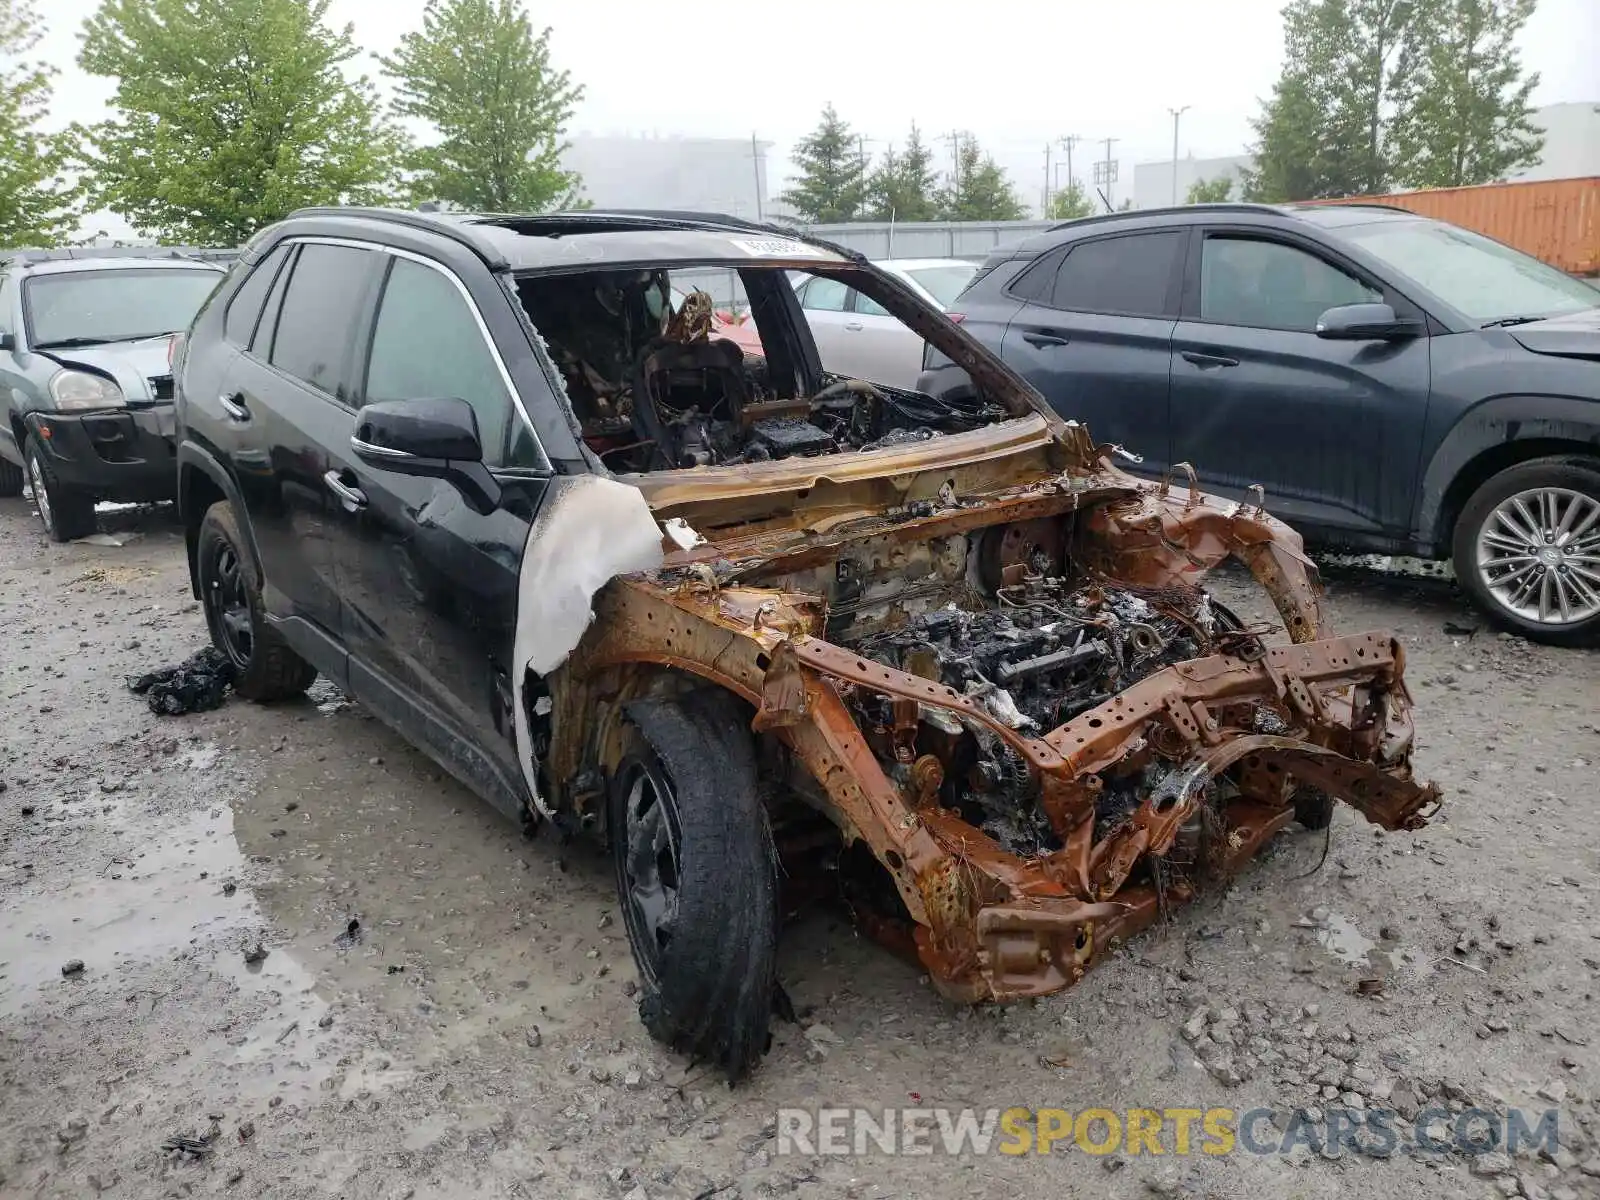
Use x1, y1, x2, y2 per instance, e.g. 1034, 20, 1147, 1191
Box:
608, 693, 778, 1082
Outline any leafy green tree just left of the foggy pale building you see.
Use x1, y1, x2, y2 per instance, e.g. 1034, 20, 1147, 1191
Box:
379, 0, 584, 213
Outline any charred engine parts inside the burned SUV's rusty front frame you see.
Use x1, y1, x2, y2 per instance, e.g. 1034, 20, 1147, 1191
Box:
786, 518, 1267, 858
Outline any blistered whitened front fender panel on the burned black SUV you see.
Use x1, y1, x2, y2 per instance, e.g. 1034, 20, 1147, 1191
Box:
514, 475, 662, 816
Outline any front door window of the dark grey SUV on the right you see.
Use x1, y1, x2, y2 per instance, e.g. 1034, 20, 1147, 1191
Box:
1200, 237, 1382, 333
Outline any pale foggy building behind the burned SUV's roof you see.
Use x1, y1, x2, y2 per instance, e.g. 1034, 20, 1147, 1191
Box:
562, 133, 771, 221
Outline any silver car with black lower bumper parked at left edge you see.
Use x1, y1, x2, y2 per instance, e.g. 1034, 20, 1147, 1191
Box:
0, 251, 222, 542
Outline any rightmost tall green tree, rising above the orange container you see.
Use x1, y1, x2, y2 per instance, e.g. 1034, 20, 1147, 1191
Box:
1394, 0, 1544, 187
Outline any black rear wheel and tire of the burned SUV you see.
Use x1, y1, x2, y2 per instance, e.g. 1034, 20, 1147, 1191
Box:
195, 501, 317, 704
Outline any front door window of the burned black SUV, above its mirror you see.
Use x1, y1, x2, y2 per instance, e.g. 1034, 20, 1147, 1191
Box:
366, 258, 533, 466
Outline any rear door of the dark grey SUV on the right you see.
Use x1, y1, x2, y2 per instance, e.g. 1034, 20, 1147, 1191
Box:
1002, 229, 1187, 474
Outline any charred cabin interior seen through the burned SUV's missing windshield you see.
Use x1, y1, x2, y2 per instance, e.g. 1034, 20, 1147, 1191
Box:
518, 270, 1006, 474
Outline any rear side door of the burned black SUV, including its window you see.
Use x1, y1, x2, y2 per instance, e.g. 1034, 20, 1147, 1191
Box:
220, 242, 381, 649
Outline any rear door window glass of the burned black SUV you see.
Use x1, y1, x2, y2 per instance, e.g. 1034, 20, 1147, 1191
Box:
269, 243, 371, 397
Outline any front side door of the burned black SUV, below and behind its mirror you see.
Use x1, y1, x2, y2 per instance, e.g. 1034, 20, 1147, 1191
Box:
328, 251, 549, 795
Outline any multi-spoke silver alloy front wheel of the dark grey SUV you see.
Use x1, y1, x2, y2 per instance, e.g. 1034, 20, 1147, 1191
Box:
1451, 458, 1600, 646
